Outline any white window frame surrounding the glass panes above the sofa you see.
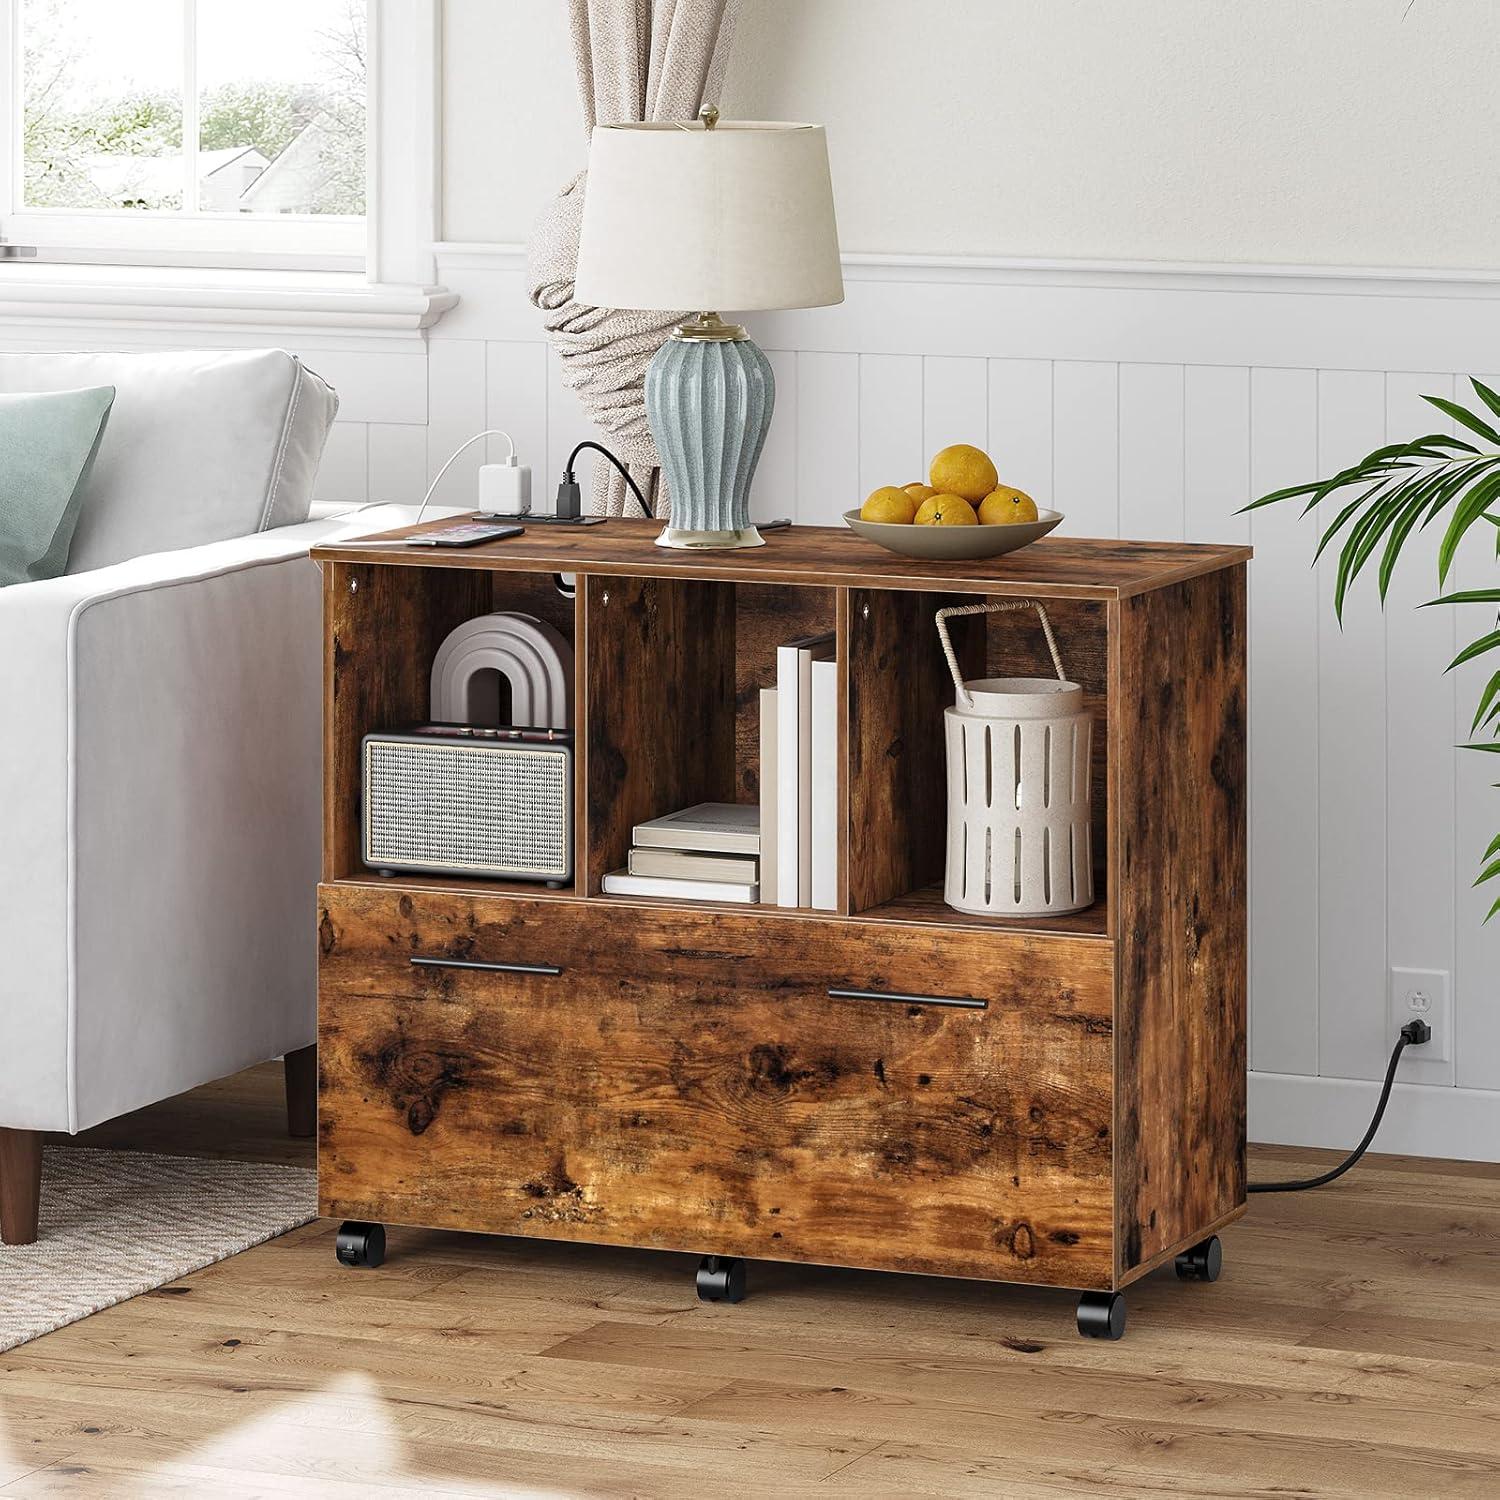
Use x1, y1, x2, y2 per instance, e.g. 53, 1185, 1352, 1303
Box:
0, 0, 441, 285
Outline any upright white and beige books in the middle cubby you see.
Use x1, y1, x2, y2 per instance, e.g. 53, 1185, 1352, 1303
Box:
761, 635, 839, 912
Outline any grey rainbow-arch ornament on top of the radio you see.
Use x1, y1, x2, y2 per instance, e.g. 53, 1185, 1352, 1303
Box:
431, 611, 573, 729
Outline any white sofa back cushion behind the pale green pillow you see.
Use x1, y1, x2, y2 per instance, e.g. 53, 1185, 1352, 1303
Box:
0, 350, 339, 573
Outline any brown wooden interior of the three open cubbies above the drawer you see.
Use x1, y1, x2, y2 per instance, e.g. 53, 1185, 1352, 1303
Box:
324, 561, 1112, 936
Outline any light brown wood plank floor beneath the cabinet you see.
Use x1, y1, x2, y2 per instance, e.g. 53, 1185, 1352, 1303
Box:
0, 1070, 1500, 1500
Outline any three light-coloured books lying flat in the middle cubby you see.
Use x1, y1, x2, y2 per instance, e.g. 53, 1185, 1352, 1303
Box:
603, 803, 761, 903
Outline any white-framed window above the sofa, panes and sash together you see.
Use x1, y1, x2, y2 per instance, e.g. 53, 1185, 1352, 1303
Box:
0, 0, 375, 269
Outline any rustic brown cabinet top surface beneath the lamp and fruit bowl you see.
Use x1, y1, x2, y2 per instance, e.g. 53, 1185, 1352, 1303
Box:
312, 516, 1251, 599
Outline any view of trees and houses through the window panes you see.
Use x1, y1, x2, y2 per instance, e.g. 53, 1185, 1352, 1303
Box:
21, 0, 368, 216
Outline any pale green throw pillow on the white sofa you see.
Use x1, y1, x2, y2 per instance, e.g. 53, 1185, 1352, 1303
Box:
0, 386, 114, 588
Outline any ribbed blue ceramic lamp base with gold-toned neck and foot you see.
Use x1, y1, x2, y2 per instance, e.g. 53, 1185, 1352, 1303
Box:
645, 314, 776, 548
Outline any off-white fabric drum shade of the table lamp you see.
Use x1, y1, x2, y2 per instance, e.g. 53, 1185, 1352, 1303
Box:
573, 120, 843, 312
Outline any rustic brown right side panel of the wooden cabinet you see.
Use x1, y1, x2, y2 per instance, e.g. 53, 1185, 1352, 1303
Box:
1112, 566, 1247, 1278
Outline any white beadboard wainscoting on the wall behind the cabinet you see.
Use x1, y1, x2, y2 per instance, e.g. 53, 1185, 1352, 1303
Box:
0, 246, 1500, 1160
